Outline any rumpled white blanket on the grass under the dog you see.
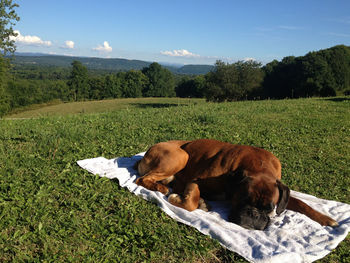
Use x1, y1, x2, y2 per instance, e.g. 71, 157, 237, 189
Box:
78, 153, 350, 263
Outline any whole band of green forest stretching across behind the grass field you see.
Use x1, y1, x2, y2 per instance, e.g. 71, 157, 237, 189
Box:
0, 45, 350, 116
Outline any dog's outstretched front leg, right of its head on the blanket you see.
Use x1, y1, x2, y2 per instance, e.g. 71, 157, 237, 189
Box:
287, 196, 339, 227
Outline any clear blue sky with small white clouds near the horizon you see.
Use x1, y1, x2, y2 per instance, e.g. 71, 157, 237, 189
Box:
15, 0, 350, 64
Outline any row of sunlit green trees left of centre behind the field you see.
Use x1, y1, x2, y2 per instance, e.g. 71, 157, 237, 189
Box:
67, 61, 176, 101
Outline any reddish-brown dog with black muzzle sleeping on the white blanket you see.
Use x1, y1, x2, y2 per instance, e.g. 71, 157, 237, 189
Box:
136, 139, 338, 230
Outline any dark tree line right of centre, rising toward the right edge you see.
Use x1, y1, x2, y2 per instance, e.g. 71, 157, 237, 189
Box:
177, 45, 350, 102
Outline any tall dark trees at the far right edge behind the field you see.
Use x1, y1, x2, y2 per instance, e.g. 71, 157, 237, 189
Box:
262, 45, 350, 98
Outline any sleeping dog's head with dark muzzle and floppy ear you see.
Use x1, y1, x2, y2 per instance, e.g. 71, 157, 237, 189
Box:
228, 172, 290, 230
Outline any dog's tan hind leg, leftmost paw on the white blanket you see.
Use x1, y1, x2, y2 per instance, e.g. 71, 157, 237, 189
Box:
136, 172, 172, 195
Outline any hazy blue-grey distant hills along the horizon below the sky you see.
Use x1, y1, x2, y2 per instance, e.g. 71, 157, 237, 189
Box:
13, 53, 214, 75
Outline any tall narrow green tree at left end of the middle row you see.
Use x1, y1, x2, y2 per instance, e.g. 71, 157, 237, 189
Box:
68, 60, 89, 101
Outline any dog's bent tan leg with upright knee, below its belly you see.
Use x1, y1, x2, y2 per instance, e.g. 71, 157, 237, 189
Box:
168, 183, 200, 211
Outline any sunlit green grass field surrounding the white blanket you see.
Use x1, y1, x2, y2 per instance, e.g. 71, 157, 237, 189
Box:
0, 97, 350, 262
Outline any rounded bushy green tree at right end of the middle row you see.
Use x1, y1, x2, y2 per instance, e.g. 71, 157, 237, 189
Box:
142, 62, 176, 97
